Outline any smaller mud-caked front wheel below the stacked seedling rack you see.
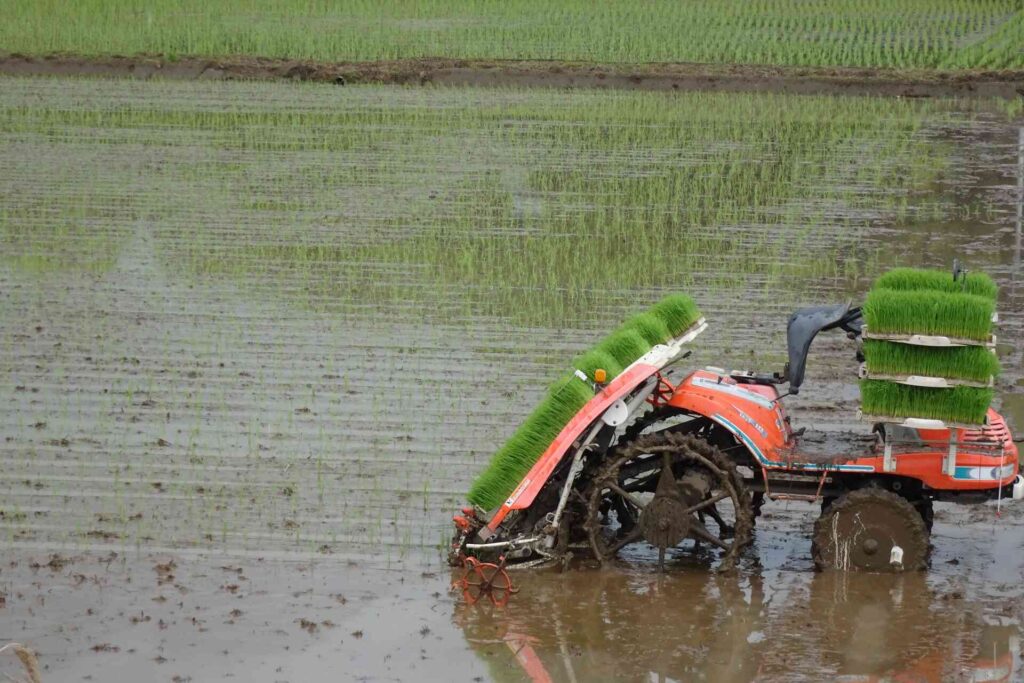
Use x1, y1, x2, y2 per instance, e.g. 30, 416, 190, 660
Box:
811, 488, 929, 572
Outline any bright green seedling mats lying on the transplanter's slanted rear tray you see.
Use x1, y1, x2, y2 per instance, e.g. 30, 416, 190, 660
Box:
467, 295, 700, 510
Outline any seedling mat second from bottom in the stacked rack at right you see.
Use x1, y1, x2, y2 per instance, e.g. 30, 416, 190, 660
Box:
864, 339, 999, 382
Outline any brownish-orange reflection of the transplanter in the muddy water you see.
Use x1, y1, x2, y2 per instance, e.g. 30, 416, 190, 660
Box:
454, 570, 1024, 683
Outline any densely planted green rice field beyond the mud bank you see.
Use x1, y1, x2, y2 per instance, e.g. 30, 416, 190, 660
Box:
0, 0, 1024, 70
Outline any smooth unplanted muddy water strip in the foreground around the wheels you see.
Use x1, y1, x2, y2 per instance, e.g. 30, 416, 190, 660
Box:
3, 504, 1024, 682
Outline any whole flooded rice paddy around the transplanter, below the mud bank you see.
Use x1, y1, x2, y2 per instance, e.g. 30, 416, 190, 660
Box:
0, 79, 1024, 681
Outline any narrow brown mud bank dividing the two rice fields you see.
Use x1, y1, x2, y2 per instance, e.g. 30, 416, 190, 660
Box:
0, 54, 1024, 98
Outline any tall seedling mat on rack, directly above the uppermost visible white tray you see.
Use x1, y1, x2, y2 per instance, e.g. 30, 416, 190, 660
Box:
863, 289, 995, 341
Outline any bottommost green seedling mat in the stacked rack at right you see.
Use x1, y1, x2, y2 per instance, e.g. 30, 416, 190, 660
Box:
860, 380, 993, 425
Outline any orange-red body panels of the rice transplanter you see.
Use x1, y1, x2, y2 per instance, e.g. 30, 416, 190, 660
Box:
487, 362, 1019, 531
